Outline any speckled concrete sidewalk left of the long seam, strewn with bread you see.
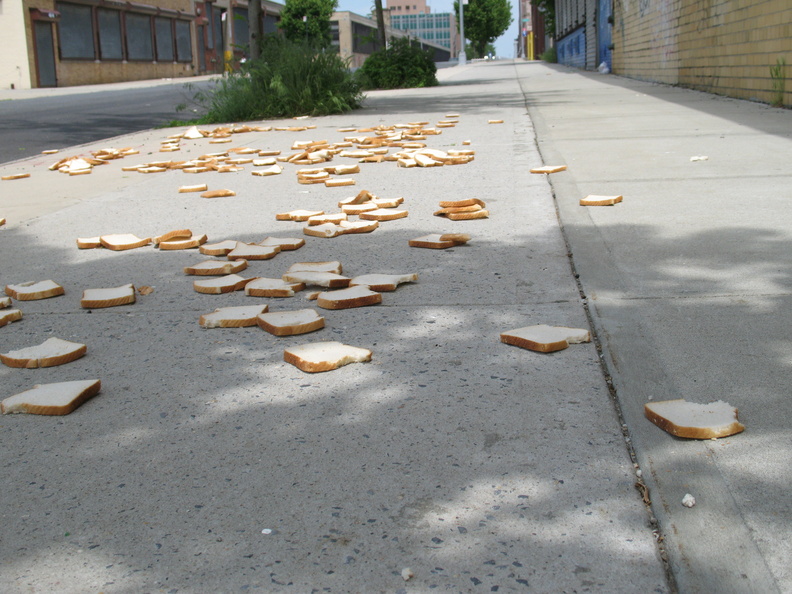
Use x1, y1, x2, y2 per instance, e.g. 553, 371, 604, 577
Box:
0, 62, 669, 592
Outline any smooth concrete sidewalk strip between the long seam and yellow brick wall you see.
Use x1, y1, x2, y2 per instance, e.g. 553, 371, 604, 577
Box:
517, 64, 792, 592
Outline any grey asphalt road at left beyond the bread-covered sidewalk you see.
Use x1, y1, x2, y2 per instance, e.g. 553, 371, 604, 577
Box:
0, 81, 210, 163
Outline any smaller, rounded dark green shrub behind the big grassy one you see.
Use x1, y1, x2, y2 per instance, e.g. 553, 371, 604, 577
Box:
358, 37, 438, 89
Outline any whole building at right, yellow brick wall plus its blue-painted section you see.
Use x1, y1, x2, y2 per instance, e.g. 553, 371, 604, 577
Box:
556, 0, 792, 105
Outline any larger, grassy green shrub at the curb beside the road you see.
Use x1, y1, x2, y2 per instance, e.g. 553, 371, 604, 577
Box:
196, 35, 363, 124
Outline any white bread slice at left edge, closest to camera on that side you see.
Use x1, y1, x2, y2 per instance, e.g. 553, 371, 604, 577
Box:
0, 380, 102, 415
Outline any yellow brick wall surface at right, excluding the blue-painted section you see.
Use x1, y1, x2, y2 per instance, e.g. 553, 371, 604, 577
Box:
613, 0, 792, 105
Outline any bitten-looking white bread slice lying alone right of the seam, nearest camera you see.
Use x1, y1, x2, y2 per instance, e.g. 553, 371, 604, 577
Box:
644, 398, 745, 439
